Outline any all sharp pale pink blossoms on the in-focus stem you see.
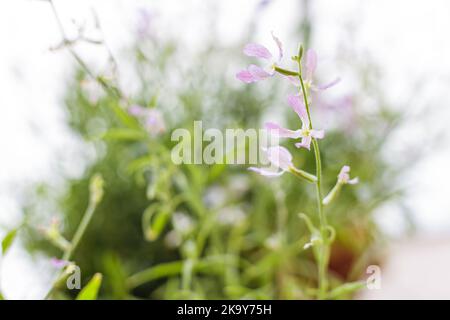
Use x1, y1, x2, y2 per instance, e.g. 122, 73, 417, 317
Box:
236, 32, 358, 192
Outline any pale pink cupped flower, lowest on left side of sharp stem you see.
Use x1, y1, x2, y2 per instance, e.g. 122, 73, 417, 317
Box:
248, 146, 294, 177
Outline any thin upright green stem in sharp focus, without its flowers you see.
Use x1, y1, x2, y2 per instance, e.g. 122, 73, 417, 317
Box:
298, 59, 330, 299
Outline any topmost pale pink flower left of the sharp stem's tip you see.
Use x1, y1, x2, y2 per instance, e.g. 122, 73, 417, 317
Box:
236, 32, 283, 83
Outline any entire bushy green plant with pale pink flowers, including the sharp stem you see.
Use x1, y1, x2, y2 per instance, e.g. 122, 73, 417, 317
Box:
2, 1, 404, 299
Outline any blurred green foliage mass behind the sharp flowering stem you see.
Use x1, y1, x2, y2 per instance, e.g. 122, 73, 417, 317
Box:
25, 8, 408, 299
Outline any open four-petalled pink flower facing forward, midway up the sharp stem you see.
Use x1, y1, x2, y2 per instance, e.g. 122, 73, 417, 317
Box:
265, 95, 325, 150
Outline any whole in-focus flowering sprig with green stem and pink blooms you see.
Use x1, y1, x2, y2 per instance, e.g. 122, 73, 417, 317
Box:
236, 34, 360, 299
